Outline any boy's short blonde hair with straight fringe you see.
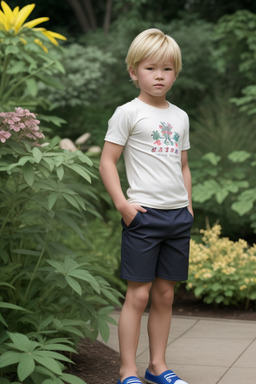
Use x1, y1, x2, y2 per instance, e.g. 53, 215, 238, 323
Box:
125, 28, 182, 85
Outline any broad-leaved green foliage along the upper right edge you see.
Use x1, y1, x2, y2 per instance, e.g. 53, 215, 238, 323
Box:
216, 10, 256, 114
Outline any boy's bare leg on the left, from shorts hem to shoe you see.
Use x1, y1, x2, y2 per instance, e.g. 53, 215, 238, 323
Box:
118, 281, 152, 382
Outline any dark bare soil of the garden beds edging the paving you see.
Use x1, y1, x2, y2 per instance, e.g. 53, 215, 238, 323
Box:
70, 291, 256, 384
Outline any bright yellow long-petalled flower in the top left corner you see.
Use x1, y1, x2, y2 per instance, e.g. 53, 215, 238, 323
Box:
0, 1, 66, 50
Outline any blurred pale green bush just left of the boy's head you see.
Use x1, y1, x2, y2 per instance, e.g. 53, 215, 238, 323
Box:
36, 43, 116, 145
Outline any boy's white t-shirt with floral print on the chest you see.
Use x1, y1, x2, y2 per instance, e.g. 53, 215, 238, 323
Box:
105, 98, 190, 209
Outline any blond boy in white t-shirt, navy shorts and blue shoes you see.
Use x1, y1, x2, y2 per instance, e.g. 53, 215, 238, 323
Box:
100, 28, 193, 384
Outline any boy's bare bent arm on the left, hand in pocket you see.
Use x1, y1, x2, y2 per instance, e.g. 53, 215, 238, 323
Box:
99, 141, 146, 225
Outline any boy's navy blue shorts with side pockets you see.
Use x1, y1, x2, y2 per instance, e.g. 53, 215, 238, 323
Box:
121, 207, 193, 282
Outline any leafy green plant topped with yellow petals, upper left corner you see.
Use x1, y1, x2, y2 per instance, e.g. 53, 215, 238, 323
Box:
0, 1, 66, 111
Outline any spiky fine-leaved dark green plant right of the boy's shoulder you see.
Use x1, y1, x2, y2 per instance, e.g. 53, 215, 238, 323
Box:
189, 88, 256, 159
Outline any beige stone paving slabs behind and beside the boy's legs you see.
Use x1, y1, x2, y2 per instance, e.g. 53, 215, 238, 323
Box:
100, 312, 256, 384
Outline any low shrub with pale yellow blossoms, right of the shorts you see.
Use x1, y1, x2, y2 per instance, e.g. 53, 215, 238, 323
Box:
186, 225, 256, 308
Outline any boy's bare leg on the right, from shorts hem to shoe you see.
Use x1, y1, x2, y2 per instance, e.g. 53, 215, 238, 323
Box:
148, 278, 175, 375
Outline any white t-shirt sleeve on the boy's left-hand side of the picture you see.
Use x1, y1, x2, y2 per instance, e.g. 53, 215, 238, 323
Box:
105, 107, 131, 146
